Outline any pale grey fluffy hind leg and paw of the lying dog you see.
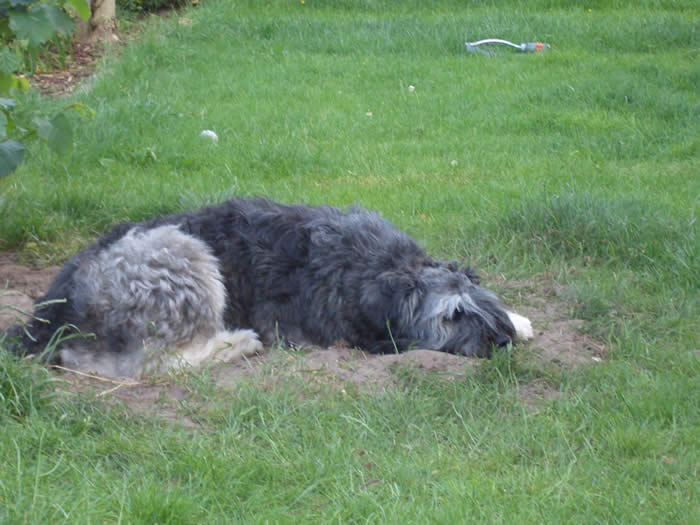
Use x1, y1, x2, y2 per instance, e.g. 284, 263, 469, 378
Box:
68, 225, 261, 377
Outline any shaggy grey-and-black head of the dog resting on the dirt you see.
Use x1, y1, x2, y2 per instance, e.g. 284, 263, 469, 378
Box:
402, 265, 515, 357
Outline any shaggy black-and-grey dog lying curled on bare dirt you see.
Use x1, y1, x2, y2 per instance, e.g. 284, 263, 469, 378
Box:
4, 199, 532, 376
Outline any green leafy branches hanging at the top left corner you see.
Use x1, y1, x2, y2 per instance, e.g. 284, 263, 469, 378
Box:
0, 0, 90, 177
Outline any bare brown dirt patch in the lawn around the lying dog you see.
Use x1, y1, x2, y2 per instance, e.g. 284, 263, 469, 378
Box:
0, 254, 605, 425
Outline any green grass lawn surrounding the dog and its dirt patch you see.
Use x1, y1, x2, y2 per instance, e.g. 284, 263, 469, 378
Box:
0, 0, 700, 524
